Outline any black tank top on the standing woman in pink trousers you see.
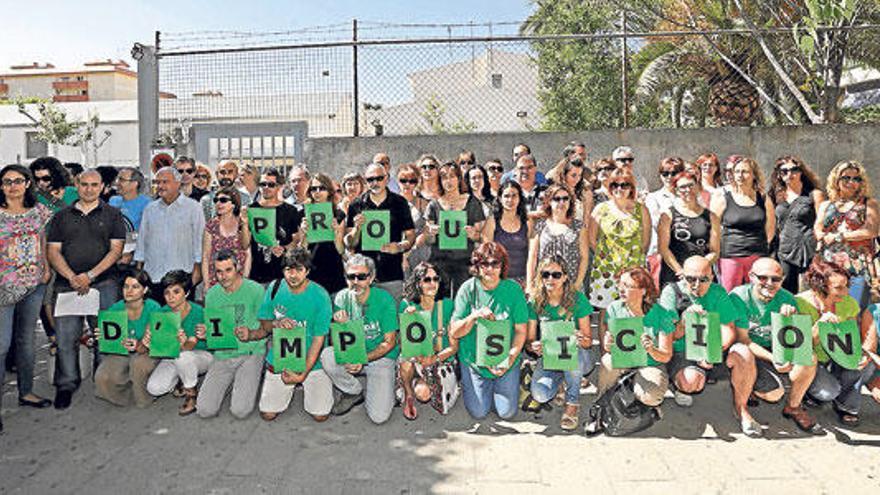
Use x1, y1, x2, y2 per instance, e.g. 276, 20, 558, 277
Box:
721, 191, 769, 258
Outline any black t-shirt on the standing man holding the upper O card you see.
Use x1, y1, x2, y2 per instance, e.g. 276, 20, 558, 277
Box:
345, 189, 415, 282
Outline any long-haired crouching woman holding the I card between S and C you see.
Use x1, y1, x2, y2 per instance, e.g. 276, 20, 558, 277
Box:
527, 255, 593, 431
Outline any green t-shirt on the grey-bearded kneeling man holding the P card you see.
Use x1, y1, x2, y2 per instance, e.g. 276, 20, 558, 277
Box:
333, 287, 400, 359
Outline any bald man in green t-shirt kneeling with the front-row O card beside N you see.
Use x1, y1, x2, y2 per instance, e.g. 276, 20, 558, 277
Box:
730, 258, 822, 434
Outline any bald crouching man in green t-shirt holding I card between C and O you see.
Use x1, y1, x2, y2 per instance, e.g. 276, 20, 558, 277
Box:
659, 256, 763, 437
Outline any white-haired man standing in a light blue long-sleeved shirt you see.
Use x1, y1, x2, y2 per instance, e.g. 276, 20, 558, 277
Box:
134, 167, 205, 303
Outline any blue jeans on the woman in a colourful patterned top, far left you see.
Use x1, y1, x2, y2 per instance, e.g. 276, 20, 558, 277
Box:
0, 284, 46, 397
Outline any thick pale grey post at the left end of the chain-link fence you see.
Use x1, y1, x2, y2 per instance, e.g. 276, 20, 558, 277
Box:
131, 35, 159, 176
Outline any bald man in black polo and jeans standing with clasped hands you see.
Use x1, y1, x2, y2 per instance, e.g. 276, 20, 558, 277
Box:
47, 170, 125, 409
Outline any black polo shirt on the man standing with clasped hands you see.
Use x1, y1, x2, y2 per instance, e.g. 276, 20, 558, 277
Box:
46, 201, 125, 290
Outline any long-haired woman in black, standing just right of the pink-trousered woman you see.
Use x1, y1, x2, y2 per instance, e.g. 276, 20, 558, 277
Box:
769, 155, 825, 294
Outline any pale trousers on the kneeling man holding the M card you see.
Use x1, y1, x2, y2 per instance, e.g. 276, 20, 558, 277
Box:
260, 370, 333, 416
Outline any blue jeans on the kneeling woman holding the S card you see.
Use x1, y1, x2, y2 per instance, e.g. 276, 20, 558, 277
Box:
460, 363, 519, 419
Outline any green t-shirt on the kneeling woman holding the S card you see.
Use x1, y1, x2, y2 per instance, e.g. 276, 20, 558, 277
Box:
452, 277, 529, 379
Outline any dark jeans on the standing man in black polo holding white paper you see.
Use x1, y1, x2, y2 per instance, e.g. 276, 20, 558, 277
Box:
55, 280, 119, 392
